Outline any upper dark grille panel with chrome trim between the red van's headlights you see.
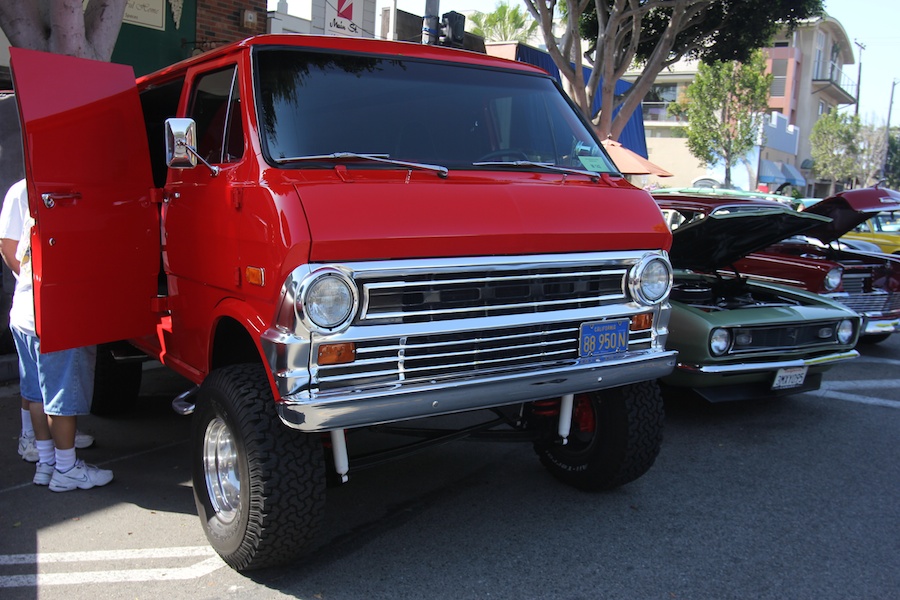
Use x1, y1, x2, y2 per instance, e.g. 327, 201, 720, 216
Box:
357, 263, 630, 325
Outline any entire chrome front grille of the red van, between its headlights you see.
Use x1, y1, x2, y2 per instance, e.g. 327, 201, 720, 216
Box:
311, 252, 655, 391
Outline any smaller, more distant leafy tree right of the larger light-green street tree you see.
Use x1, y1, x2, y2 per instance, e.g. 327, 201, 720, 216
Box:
809, 110, 861, 196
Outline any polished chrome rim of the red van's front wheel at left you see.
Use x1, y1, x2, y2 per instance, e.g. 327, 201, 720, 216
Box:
203, 417, 241, 523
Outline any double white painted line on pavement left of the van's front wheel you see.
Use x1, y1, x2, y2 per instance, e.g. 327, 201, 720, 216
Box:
0, 546, 225, 588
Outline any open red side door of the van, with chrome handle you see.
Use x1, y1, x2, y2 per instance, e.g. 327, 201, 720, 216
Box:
10, 48, 160, 352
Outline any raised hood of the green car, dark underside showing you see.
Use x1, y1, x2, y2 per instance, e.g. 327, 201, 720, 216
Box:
669, 206, 829, 272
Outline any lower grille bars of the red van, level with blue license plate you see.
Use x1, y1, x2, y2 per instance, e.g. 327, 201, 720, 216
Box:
316, 322, 652, 391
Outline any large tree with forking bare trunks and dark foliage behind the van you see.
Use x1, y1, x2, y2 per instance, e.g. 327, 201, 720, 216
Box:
523, 0, 822, 138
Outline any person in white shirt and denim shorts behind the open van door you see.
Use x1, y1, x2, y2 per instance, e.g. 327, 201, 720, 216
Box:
0, 179, 113, 492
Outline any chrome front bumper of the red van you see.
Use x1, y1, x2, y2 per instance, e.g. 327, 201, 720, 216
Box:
277, 351, 677, 432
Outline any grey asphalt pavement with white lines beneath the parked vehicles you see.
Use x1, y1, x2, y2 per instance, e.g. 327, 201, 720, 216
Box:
0, 336, 900, 600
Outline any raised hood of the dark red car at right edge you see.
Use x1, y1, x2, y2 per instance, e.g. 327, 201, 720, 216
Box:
803, 188, 900, 244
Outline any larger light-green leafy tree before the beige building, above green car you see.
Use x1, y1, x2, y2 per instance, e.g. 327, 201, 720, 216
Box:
675, 50, 772, 187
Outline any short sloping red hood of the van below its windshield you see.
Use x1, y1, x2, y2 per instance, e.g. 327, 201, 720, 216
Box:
295, 171, 671, 262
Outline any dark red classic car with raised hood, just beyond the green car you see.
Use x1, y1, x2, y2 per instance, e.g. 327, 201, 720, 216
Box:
654, 187, 900, 343
